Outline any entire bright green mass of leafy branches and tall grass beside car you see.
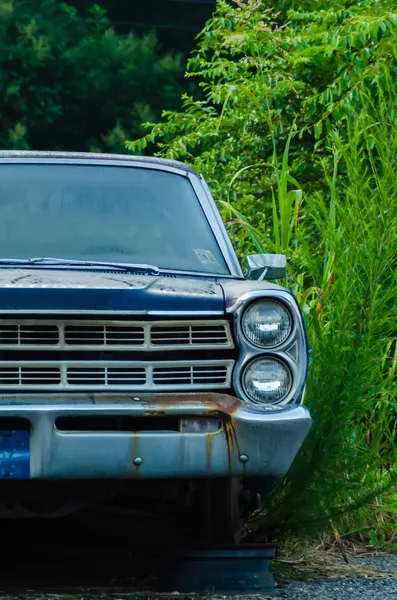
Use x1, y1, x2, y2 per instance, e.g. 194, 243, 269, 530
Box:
128, 0, 397, 535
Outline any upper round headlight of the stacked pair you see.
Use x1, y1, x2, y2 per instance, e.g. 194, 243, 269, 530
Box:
242, 300, 292, 348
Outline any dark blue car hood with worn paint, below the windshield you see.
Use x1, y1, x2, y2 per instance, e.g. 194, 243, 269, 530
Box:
0, 268, 225, 314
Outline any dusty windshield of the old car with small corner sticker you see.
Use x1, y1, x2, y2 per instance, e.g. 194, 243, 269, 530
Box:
0, 164, 229, 275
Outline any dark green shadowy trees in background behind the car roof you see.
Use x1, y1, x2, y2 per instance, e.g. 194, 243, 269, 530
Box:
0, 0, 183, 151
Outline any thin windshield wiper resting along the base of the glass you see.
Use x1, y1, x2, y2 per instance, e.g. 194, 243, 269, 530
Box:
0, 256, 160, 275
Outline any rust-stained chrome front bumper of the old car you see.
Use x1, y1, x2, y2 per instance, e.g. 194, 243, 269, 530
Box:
0, 393, 311, 479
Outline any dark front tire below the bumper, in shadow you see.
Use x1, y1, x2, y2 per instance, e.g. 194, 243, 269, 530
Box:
199, 477, 242, 544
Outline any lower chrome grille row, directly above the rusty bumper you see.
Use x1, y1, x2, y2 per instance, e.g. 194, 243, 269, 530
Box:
0, 360, 234, 392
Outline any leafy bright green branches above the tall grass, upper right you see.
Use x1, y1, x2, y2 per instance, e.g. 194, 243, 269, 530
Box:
128, 0, 397, 227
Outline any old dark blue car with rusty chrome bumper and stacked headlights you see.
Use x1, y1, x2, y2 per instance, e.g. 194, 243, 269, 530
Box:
0, 151, 311, 543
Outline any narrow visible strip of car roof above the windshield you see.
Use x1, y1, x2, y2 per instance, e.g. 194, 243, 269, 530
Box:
0, 150, 197, 175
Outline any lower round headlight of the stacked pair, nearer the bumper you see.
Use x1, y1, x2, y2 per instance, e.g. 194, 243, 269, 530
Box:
242, 357, 292, 404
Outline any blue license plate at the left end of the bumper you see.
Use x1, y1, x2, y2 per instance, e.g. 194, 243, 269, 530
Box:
0, 430, 30, 479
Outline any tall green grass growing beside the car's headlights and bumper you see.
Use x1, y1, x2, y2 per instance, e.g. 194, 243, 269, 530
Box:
224, 101, 397, 535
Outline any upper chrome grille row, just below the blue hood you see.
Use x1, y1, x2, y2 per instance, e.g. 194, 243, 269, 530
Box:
0, 320, 234, 350
